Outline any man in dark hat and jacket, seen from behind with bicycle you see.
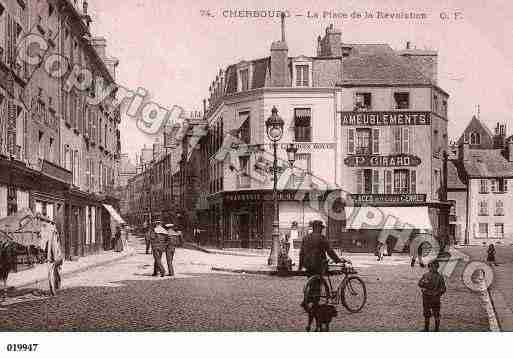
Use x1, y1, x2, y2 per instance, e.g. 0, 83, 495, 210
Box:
298, 220, 351, 310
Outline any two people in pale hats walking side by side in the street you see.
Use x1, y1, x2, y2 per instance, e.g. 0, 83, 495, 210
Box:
145, 220, 181, 277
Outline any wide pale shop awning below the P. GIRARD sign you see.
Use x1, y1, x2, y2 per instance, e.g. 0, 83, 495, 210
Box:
346, 206, 433, 230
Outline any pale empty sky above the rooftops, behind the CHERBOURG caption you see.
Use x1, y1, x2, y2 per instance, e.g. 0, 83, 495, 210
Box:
85, 0, 513, 159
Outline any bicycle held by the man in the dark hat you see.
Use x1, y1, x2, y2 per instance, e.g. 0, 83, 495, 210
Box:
304, 262, 367, 313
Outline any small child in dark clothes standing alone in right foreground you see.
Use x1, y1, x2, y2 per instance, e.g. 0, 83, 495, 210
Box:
419, 260, 446, 332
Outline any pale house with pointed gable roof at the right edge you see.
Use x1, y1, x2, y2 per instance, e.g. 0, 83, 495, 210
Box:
448, 117, 513, 245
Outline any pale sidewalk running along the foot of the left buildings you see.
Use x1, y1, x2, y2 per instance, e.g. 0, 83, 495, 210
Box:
7, 236, 139, 288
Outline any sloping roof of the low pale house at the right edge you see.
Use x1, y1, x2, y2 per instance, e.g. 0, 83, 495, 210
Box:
463, 149, 513, 178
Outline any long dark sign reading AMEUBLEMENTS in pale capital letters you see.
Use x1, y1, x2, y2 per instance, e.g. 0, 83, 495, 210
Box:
340, 111, 431, 126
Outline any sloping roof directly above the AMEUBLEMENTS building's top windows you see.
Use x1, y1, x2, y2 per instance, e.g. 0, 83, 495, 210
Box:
341, 44, 434, 85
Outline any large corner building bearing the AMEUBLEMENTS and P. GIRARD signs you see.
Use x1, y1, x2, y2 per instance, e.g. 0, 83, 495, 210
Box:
198, 24, 448, 251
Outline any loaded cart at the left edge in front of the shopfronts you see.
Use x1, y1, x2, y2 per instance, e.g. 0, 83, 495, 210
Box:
0, 209, 63, 299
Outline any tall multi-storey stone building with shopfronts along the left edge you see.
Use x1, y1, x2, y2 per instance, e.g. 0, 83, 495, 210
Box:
0, 0, 120, 258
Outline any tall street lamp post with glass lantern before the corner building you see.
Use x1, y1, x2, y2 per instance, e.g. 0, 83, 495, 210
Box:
265, 106, 285, 266
